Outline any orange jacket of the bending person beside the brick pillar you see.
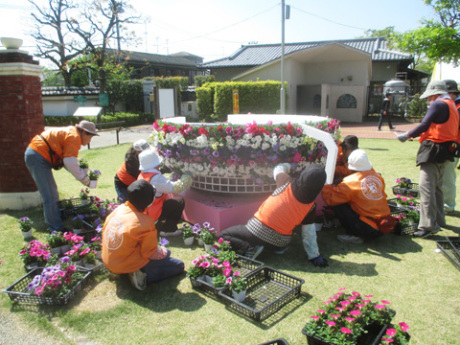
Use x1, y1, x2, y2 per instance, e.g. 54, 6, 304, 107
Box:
29, 127, 81, 163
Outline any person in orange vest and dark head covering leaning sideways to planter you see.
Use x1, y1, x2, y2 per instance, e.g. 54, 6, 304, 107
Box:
220, 163, 327, 267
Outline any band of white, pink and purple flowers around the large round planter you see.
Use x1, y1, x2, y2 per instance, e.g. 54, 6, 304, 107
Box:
152, 120, 339, 184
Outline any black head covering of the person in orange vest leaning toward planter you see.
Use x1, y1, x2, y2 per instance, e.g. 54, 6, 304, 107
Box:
292, 164, 326, 204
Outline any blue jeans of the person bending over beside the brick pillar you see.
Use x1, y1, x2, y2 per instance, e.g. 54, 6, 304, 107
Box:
24, 147, 64, 231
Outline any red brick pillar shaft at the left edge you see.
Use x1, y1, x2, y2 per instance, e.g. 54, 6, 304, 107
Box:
0, 72, 45, 193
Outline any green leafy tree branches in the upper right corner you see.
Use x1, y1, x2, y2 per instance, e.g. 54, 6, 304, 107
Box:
392, 0, 460, 63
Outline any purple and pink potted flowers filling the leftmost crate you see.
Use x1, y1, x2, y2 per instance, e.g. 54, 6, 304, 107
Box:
27, 257, 84, 297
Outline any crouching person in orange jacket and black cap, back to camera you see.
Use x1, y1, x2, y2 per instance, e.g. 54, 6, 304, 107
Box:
102, 180, 184, 290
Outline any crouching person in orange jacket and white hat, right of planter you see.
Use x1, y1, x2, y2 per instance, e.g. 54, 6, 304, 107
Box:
321, 149, 396, 243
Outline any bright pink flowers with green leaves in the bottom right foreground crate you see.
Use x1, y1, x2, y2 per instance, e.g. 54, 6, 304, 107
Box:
305, 288, 394, 345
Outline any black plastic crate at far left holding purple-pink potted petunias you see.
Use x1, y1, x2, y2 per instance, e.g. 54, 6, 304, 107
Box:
3, 268, 91, 305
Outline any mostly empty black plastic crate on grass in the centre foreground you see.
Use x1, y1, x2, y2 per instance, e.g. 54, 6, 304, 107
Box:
219, 267, 305, 321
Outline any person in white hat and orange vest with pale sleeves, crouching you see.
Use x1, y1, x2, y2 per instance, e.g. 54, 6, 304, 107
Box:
138, 149, 193, 237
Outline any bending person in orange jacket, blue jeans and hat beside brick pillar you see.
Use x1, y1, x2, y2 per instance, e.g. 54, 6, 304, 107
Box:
24, 120, 99, 232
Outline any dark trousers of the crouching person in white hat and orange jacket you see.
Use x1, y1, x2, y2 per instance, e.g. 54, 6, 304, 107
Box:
330, 204, 383, 240
